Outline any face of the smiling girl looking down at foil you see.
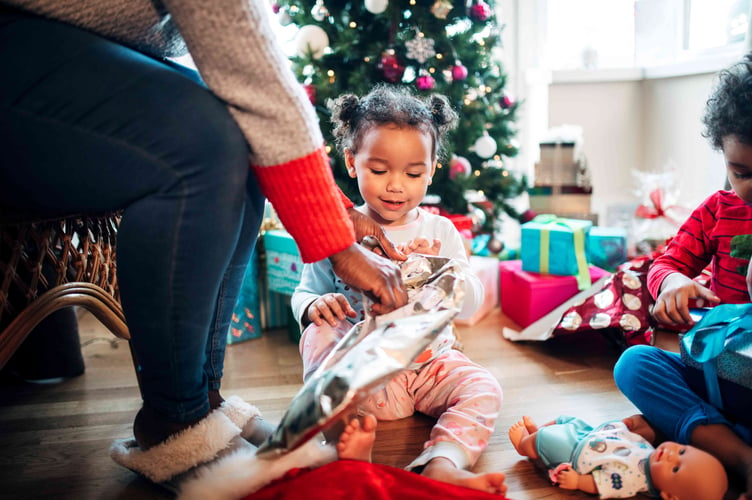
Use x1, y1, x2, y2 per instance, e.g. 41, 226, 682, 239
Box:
345, 125, 436, 226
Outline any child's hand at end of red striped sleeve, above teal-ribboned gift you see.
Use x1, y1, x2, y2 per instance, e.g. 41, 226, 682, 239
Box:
653, 273, 721, 325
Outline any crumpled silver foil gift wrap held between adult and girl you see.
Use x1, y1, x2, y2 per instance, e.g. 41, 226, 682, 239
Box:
257, 254, 464, 458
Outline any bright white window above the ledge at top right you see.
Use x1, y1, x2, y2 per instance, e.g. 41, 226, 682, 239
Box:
545, 0, 752, 70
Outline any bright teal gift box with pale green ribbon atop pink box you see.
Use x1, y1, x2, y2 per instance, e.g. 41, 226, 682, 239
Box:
520, 214, 593, 290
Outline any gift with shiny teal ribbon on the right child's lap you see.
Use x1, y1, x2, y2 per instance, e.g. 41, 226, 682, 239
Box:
679, 303, 752, 408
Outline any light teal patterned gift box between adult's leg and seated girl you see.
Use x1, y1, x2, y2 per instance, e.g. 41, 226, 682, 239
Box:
263, 229, 303, 295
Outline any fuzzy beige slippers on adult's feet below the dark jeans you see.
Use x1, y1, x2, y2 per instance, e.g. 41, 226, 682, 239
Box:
110, 397, 259, 484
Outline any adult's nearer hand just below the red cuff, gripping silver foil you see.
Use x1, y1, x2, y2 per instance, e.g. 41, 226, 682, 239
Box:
329, 243, 407, 314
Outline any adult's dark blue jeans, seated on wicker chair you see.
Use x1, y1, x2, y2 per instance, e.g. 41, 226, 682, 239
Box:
0, 11, 264, 422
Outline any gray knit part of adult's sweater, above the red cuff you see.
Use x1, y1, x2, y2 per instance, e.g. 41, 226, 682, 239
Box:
0, 0, 323, 165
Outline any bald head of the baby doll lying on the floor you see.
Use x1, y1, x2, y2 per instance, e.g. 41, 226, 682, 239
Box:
649, 441, 728, 500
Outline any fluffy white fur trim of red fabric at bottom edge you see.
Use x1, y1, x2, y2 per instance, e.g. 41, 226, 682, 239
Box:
178, 432, 337, 500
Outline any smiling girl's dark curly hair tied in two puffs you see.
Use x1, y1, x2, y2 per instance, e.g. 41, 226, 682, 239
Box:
327, 84, 458, 160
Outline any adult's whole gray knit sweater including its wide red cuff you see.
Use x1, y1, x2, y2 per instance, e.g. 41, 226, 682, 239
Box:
0, 0, 354, 262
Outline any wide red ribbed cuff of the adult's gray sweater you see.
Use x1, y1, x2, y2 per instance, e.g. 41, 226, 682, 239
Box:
252, 146, 355, 262
